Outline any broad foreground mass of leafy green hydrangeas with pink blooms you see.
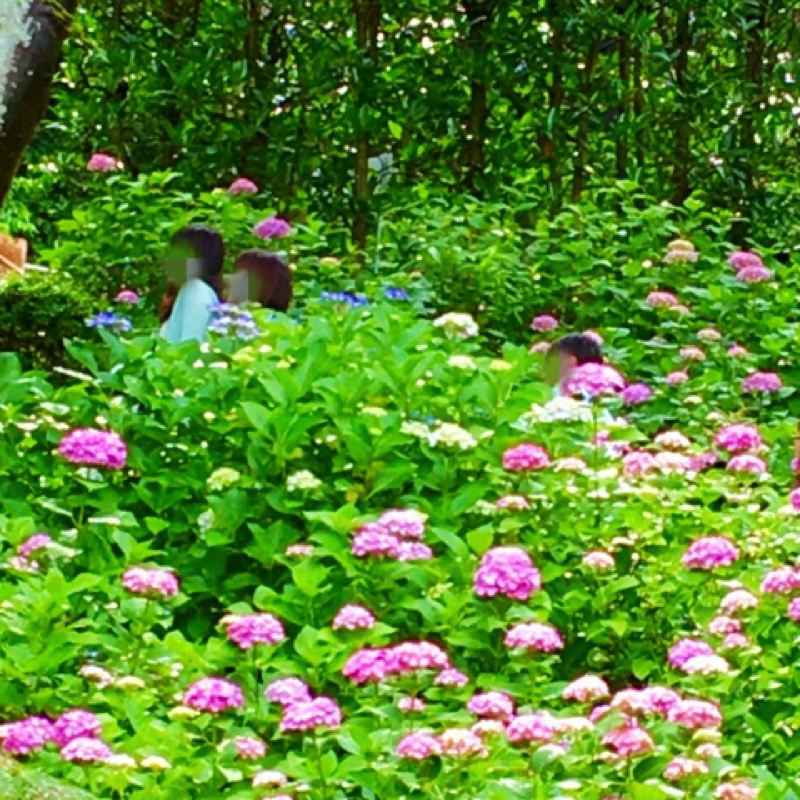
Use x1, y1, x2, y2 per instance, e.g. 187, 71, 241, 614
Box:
0, 248, 800, 800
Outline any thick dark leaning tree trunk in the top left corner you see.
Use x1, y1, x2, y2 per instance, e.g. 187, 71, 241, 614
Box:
0, 0, 77, 205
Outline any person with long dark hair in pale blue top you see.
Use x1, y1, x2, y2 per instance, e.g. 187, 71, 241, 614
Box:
159, 225, 225, 344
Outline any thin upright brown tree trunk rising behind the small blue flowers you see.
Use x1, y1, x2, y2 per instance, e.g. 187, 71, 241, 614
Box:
353, 0, 381, 258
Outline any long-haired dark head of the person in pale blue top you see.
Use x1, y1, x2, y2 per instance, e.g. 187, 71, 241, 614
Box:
159, 225, 225, 322
